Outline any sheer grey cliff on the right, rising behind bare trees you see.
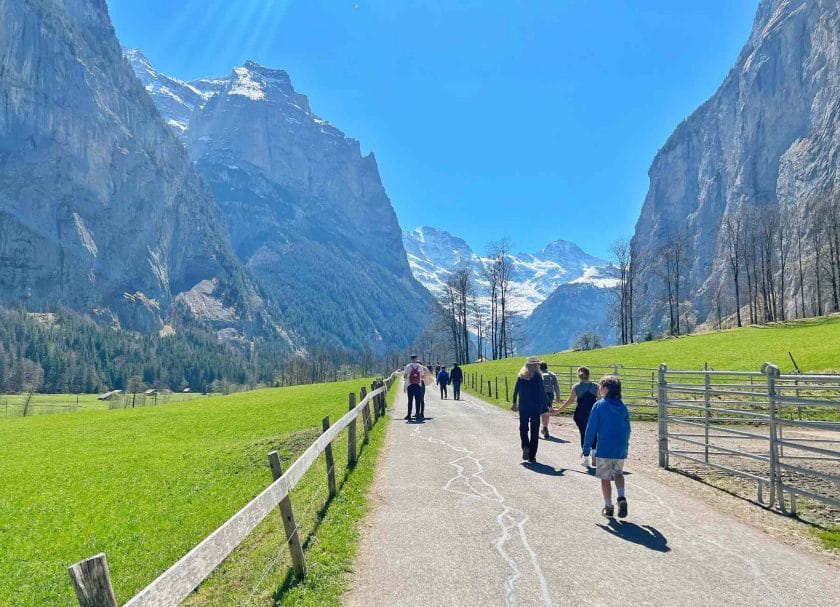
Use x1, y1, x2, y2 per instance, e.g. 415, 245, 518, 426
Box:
633, 0, 840, 332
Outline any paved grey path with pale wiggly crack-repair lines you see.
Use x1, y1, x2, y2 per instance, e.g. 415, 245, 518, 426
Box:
345, 386, 840, 607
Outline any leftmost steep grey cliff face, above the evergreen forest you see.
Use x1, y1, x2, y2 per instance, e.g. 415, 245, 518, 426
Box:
0, 0, 261, 330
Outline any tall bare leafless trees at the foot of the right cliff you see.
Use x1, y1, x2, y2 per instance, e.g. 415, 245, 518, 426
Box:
611, 194, 840, 344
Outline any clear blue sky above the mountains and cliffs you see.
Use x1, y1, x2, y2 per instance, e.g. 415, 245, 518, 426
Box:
108, 0, 758, 255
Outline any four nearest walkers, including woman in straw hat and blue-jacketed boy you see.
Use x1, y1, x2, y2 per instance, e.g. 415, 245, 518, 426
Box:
512, 356, 630, 518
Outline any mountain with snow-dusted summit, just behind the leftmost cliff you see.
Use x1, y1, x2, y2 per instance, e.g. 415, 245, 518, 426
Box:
132, 57, 432, 350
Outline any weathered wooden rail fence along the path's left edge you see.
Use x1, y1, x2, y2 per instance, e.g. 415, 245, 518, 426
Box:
69, 373, 398, 607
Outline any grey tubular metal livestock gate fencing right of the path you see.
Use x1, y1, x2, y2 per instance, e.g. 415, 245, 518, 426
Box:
658, 363, 840, 515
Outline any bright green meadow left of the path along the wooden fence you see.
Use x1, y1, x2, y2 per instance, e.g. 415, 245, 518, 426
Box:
0, 380, 384, 607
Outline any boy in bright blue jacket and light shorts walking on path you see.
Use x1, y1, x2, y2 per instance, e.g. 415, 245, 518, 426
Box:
583, 375, 630, 518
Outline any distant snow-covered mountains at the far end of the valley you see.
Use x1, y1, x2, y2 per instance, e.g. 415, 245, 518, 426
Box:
403, 226, 618, 318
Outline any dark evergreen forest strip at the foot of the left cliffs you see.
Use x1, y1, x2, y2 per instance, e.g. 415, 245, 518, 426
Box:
0, 309, 384, 394
